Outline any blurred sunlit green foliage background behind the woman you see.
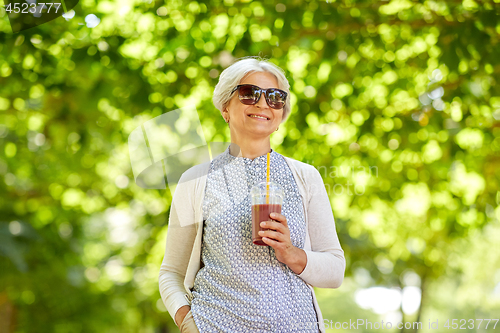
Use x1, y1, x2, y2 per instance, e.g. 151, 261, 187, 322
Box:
0, 0, 500, 333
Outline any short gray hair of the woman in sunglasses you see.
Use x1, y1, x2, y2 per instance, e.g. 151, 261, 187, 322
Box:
212, 57, 291, 123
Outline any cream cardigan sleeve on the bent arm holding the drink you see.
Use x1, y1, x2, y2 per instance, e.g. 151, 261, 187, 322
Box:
299, 167, 346, 288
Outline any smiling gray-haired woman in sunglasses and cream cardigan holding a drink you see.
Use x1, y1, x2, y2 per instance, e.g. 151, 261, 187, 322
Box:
159, 57, 345, 333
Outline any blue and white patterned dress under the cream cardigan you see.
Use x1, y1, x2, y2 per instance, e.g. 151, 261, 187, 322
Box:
191, 148, 318, 333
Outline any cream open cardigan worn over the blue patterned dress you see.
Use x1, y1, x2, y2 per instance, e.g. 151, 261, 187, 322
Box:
159, 156, 345, 332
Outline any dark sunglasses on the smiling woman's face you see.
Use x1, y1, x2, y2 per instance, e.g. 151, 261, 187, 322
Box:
231, 84, 287, 109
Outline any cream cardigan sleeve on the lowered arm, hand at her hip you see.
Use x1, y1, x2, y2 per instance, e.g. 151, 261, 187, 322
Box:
159, 174, 196, 322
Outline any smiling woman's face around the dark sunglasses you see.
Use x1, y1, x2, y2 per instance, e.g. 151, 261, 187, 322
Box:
225, 72, 283, 138
